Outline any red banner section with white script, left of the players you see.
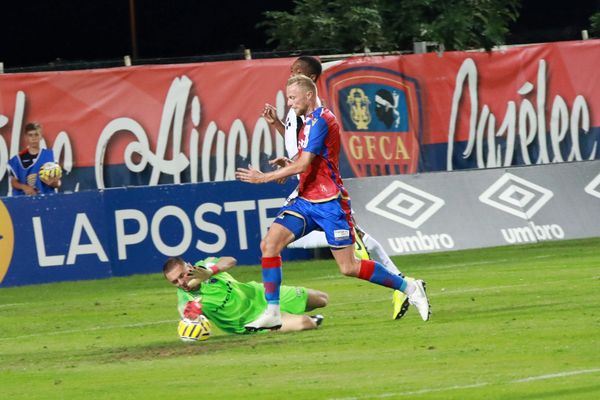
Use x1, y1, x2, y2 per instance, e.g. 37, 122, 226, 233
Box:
0, 59, 293, 192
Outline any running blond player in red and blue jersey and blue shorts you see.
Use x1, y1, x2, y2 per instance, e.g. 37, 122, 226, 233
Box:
236, 75, 430, 330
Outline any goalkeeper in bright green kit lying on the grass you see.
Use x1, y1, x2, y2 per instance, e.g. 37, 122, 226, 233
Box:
163, 257, 328, 333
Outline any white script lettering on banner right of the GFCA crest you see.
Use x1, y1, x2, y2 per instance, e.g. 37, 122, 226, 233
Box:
446, 58, 597, 171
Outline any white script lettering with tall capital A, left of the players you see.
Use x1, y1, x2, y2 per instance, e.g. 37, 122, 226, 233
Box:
95, 75, 285, 189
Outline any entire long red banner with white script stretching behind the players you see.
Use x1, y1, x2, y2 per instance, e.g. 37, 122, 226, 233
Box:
0, 40, 600, 195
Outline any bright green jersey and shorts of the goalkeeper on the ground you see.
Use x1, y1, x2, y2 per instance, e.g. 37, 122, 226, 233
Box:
177, 258, 308, 333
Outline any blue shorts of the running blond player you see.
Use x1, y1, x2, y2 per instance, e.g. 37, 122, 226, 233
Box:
274, 197, 354, 248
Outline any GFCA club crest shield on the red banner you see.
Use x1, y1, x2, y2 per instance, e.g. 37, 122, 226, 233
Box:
326, 66, 422, 176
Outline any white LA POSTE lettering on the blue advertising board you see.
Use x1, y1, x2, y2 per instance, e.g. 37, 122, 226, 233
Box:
32, 197, 285, 267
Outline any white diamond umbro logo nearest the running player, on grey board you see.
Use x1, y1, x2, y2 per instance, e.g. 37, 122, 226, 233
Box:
366, 181, 445, 229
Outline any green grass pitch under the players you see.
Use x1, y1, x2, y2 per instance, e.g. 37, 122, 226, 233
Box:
0, 238, 600, 400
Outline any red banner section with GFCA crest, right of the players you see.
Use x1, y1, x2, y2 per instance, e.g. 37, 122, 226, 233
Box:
320, 40, 600, 176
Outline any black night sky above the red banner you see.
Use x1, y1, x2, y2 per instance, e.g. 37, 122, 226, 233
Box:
0, 0, 600, 71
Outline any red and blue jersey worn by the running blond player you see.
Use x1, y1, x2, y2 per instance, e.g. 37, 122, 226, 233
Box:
298, 107, 348, 203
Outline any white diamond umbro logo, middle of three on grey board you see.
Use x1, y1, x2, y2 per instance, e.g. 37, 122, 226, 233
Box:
479, 173, 554, 219
